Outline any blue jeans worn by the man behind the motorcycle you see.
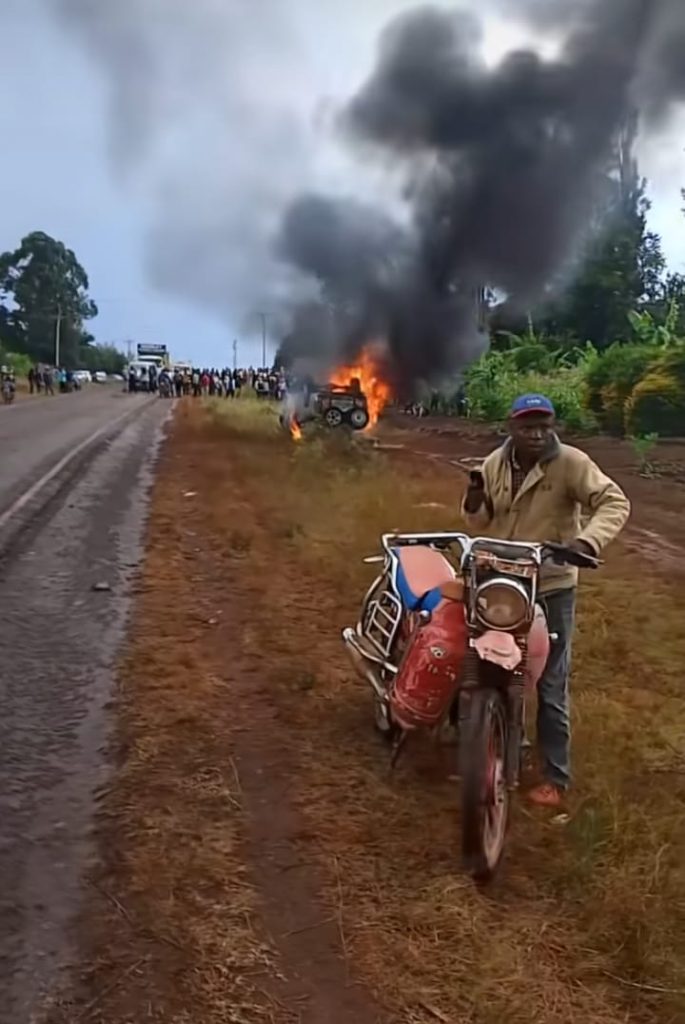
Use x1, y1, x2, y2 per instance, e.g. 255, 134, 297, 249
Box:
538, 588, 575, 790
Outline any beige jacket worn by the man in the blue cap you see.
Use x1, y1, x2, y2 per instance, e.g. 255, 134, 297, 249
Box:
462, 440, 631, 593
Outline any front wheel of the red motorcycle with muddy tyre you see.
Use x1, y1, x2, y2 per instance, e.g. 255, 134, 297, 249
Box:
461, 689, 510, 882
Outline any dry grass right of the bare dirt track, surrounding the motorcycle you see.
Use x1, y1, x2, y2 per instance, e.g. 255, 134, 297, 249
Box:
207, 404, 685, 1024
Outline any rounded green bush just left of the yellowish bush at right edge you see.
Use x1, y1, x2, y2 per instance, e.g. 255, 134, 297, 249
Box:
586, 342, 659, 435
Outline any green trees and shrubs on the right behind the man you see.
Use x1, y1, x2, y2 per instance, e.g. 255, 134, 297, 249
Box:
454, 149, 685, 437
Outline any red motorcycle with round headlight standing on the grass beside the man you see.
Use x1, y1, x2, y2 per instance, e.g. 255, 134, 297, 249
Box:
342, 532, 600, 882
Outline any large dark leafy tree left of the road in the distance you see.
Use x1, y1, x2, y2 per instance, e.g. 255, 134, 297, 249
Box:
0, 231, 97, 366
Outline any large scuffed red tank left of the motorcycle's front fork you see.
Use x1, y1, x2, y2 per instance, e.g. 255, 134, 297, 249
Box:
390, 599, 467, 729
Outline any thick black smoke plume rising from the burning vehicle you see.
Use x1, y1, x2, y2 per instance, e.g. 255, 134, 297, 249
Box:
279, 0, 685, 380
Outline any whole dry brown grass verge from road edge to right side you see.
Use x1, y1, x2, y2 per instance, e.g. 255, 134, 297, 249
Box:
53, 398, 685, 1024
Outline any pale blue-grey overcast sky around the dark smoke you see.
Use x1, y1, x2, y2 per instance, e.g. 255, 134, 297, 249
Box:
0, 0, 685, 365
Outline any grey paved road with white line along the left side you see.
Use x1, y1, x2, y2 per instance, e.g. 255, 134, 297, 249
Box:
0, 389, 169, 1024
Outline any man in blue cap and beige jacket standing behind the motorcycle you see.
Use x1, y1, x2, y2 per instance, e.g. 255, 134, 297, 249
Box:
463, 394, 631, 807
